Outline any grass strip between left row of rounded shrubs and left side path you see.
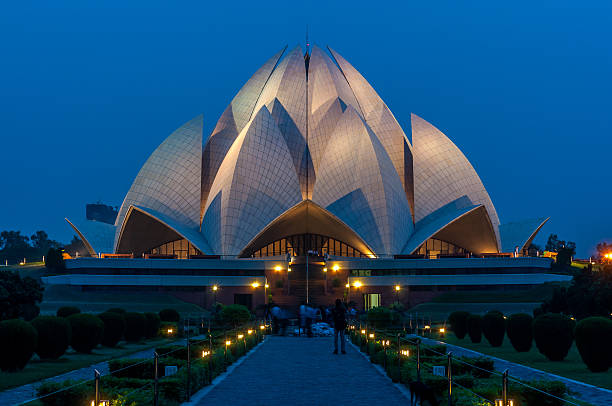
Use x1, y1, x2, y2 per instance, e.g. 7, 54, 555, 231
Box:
0, 338, 172, 391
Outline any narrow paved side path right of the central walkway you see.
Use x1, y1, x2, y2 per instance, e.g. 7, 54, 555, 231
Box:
421, 337, 612, 406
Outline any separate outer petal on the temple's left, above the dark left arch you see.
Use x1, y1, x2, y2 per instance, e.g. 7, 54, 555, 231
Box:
115, 115, 207, 251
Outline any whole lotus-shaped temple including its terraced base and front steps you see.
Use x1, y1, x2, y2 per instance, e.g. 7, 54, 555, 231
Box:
46, 46, 564, 309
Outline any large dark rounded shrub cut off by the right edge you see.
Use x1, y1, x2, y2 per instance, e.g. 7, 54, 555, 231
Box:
574, 317, 612, 372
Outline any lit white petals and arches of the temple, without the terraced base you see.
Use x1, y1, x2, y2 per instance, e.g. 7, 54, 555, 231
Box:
69, 46, 547, 259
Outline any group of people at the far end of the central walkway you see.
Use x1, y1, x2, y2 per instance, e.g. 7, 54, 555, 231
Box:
268, 299, 355, 354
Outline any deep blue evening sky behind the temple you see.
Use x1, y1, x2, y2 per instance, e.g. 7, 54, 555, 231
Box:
0, 0, 612, 257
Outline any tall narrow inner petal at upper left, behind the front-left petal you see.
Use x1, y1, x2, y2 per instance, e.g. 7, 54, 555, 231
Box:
200, 48, 286, 215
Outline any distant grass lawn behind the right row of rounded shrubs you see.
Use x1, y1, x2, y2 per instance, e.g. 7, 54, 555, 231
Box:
408, 302, 541, 321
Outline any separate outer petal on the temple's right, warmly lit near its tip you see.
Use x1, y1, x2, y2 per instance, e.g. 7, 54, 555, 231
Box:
412, 114, 500, 249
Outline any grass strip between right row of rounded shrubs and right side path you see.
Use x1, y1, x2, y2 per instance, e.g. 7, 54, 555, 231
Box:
441, 333, 612, 389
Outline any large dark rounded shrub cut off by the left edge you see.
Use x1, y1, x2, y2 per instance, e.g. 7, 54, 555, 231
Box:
0, 319, 38, 372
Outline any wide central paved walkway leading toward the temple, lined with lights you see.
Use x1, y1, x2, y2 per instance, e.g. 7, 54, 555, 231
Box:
197, 337, 409, 406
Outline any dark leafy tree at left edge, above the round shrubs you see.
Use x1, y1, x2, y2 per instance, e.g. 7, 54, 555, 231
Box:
0, 271, 44, 320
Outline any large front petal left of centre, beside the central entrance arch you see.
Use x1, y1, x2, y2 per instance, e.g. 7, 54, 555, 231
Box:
202, 106, 302, 255
